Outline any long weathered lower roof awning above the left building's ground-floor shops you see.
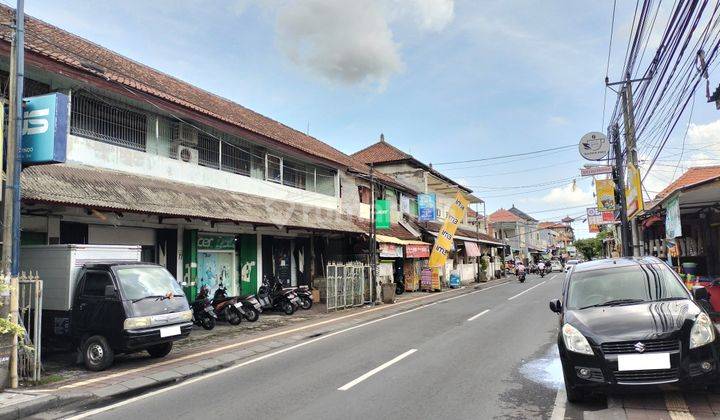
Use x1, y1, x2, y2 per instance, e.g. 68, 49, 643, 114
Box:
22, 164, 363, 233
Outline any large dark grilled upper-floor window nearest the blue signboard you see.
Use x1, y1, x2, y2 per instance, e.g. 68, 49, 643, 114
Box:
70, 93, 147, 151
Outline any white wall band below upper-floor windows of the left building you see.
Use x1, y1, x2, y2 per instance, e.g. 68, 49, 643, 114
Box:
67, 136, 338, 210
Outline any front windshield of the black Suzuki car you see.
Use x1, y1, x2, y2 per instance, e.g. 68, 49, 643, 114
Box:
567, 263, 689, 309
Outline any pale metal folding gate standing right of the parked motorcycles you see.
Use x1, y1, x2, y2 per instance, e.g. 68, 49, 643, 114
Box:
325, 262, 373, 311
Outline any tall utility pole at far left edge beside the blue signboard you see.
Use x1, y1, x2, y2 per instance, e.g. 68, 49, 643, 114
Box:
2, 0, 25, 388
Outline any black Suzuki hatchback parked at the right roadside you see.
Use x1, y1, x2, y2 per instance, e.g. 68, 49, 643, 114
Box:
550, 257, 720, 402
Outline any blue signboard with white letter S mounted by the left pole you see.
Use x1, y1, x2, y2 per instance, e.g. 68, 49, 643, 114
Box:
21, 93, 69, 165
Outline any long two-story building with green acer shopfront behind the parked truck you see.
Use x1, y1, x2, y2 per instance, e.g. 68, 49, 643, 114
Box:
0, 6, 412, 299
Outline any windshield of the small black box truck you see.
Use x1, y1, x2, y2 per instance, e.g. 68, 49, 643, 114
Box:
115, 267, 183, 300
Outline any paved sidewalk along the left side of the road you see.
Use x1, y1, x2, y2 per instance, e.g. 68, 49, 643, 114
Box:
0, 278, 509, 419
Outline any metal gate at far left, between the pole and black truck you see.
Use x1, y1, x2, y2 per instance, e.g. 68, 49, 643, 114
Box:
18, 273, 43, 383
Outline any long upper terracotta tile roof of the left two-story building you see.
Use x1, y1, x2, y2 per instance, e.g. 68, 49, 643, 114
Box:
0, 5, 406, 194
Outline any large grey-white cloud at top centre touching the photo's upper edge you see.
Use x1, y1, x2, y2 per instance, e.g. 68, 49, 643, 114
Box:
275, 0, 455, 90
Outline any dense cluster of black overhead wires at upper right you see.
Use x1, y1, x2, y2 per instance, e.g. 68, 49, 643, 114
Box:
610, 0, 720, 184
